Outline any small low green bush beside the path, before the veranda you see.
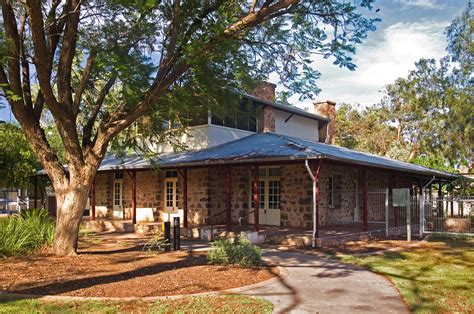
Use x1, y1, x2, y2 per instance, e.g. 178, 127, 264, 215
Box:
207, 237, 262, 267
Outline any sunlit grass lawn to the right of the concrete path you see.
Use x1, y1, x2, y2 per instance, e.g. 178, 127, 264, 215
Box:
339, 238, 474, 313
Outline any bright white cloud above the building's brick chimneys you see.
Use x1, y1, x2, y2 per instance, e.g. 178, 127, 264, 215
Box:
291, 20, 449, 108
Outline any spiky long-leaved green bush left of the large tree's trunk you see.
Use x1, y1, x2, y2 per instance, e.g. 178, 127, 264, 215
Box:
0, 209, 55, 257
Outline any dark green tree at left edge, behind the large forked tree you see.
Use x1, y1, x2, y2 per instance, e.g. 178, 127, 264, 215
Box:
0, 123, 39, 188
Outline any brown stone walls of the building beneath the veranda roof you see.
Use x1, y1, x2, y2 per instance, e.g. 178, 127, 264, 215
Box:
91, 162, 418, 228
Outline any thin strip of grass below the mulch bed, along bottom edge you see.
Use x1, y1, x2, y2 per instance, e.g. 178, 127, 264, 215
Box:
0, 295, 273, 313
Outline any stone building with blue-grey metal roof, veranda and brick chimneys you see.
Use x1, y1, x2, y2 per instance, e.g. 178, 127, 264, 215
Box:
39, 84, 455, 245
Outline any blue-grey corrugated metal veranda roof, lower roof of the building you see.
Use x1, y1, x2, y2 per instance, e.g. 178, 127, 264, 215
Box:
38, 133, 457, 179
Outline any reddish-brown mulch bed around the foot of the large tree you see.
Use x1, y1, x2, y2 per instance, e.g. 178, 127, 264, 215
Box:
0, 235, 276, 297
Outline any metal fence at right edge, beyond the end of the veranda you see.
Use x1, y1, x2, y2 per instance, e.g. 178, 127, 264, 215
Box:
422, 196, 474, 233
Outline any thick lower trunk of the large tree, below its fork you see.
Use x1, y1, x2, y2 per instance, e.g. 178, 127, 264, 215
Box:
53, 180, 91, 256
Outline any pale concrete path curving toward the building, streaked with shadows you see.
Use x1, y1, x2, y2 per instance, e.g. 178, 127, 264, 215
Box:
243, 249, 408, 313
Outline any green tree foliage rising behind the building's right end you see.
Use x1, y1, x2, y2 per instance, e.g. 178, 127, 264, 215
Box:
337, 3, 474, 171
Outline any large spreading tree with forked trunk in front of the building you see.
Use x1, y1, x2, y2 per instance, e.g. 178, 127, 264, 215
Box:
0, 0, 377, 255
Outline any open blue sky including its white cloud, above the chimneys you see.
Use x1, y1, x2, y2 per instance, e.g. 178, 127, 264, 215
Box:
0, 0, 468, 121
